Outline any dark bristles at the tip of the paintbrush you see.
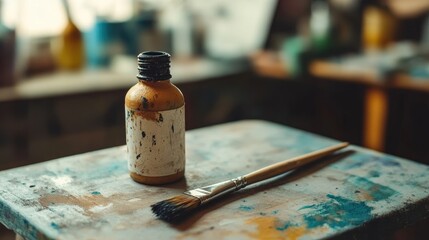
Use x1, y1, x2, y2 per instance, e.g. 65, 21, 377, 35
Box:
150, 195, 201, 223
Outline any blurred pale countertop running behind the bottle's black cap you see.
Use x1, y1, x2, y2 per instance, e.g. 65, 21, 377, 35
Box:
0, 57, 246, 102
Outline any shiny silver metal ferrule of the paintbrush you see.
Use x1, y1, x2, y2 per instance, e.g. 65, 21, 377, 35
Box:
184, 177, 247, 204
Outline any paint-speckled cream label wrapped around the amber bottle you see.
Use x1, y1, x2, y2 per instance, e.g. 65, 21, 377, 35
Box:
125, 106, 185, 177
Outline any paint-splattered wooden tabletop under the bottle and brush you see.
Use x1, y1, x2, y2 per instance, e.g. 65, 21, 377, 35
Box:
0, 120, 429, 239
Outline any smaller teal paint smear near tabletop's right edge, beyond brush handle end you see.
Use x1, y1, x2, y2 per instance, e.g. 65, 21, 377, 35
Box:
347, 176, 398, 201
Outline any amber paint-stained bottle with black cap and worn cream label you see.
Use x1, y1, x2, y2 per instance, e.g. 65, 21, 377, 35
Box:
125, 51, 185, 185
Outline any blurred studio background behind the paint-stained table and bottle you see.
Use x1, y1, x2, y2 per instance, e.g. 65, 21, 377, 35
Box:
0, 0, 429, 239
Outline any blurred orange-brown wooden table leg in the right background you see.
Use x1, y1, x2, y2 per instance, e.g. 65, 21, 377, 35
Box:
363, 87, 388, 151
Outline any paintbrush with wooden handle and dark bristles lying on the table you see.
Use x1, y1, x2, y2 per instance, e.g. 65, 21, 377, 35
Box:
151, 142, 349, 223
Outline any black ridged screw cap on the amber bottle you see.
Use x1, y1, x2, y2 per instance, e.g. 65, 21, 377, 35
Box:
137, 51, 171, 81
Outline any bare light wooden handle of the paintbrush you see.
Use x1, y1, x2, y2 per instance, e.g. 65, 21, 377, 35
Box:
243, 142, 349, 185
